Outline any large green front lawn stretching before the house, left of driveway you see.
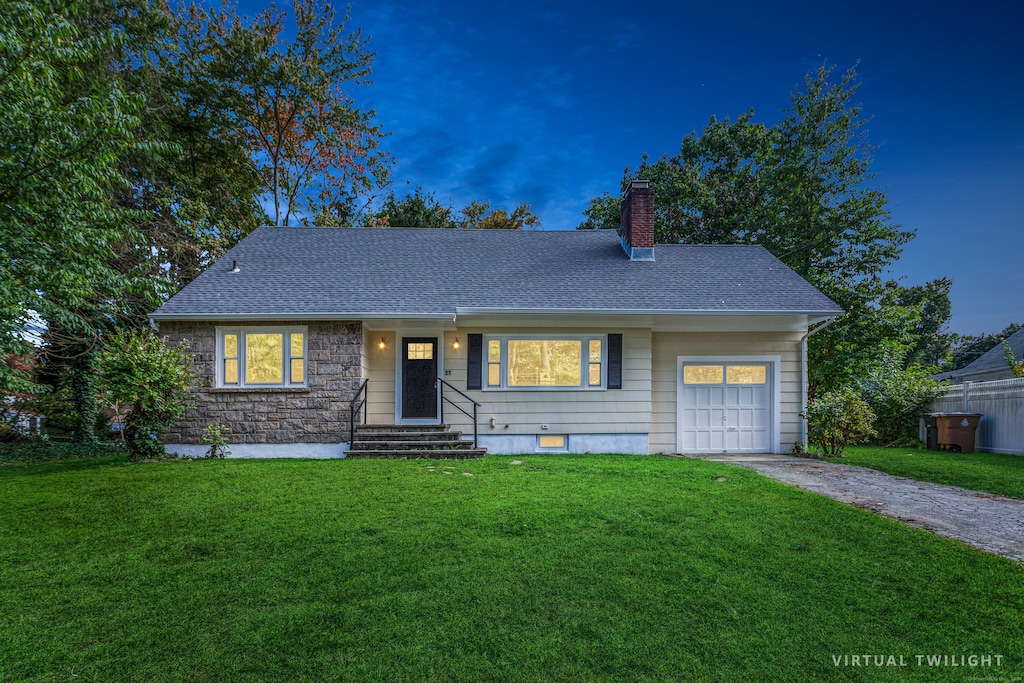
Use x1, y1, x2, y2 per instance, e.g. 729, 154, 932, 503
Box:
0, 456, 1024, 681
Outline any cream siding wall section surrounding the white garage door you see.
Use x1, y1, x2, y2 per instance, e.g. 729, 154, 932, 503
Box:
650, 332, 802, 453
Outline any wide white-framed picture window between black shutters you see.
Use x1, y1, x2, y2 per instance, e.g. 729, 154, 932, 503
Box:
483, 335, 608, 389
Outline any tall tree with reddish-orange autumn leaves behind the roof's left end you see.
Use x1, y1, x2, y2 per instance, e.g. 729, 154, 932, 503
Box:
189, 0, 391, 225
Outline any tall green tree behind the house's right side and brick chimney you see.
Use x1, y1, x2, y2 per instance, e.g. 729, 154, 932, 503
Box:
580, 65, 921, 392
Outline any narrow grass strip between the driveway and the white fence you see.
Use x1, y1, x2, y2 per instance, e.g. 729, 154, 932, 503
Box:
826, 446, 1024, 499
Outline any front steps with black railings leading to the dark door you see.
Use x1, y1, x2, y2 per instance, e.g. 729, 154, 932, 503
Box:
345, 425, 487, 460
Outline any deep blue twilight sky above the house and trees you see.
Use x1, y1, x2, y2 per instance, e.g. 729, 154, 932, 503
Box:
243, 0, 1024, 334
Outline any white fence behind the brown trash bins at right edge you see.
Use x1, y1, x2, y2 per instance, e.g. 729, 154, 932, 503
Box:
931, 378, 1024, 456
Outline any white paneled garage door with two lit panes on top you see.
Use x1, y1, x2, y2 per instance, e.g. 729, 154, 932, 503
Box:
679, 361, 772, 453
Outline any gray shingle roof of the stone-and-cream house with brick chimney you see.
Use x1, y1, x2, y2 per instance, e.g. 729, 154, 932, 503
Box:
153, 227, 841, 319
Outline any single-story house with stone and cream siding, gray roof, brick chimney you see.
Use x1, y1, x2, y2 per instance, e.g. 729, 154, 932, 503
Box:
151, 181, 842, 457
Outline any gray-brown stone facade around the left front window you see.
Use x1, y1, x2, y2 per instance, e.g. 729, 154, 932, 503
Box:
160, 321, 362, 444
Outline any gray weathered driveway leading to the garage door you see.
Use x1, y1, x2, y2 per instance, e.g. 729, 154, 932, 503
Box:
689, 455, 1024, 562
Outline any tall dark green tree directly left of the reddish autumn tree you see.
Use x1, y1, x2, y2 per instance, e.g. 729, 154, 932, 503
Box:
117, 0, 268, 299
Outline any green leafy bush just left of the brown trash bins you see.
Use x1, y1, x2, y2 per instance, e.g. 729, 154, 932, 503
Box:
857, 348, 943, 446
